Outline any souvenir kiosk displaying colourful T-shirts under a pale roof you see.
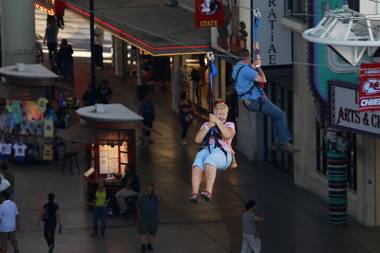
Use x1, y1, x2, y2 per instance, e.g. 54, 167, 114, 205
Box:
0, 64, 58, 162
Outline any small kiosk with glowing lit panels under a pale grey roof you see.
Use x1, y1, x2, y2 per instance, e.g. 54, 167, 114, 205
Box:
62, 104, 142, 209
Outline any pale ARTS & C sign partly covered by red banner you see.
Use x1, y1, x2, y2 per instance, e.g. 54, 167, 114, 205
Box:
329, 84, 380, 135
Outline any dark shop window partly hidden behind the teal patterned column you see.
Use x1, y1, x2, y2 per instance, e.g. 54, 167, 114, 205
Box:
316, 122, 357, 191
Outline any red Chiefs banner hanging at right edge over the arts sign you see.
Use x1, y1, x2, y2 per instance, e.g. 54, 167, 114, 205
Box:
359, 63, 380, 112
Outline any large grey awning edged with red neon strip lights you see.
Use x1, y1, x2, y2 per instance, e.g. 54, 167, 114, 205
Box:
66, 0, 211, 56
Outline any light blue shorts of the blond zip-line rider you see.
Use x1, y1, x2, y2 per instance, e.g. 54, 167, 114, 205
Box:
193, 145, 232, 172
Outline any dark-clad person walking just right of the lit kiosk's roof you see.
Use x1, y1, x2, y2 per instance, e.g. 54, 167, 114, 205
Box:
139, 93, 155, 144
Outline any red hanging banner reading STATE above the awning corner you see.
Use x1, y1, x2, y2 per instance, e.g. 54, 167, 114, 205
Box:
195, 0, 224, 28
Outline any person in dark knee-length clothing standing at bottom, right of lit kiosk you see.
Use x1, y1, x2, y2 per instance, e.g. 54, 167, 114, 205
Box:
137, 183, 160, 252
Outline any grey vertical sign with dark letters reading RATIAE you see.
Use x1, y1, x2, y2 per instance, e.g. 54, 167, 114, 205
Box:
252, 0, 292, 65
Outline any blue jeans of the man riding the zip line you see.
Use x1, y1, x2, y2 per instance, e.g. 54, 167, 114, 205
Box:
248, 95, 291, 144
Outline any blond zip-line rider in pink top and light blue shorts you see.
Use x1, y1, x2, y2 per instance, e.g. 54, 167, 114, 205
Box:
190, 102, 236, 203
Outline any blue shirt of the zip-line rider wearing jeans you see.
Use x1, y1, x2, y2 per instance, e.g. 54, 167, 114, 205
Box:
232, 62, 262, 100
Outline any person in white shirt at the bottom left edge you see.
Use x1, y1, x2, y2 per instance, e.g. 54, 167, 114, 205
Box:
0, 191, 20, 253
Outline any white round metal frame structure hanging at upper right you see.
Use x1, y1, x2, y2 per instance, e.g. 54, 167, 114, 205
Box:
303, 5, 380, 66
